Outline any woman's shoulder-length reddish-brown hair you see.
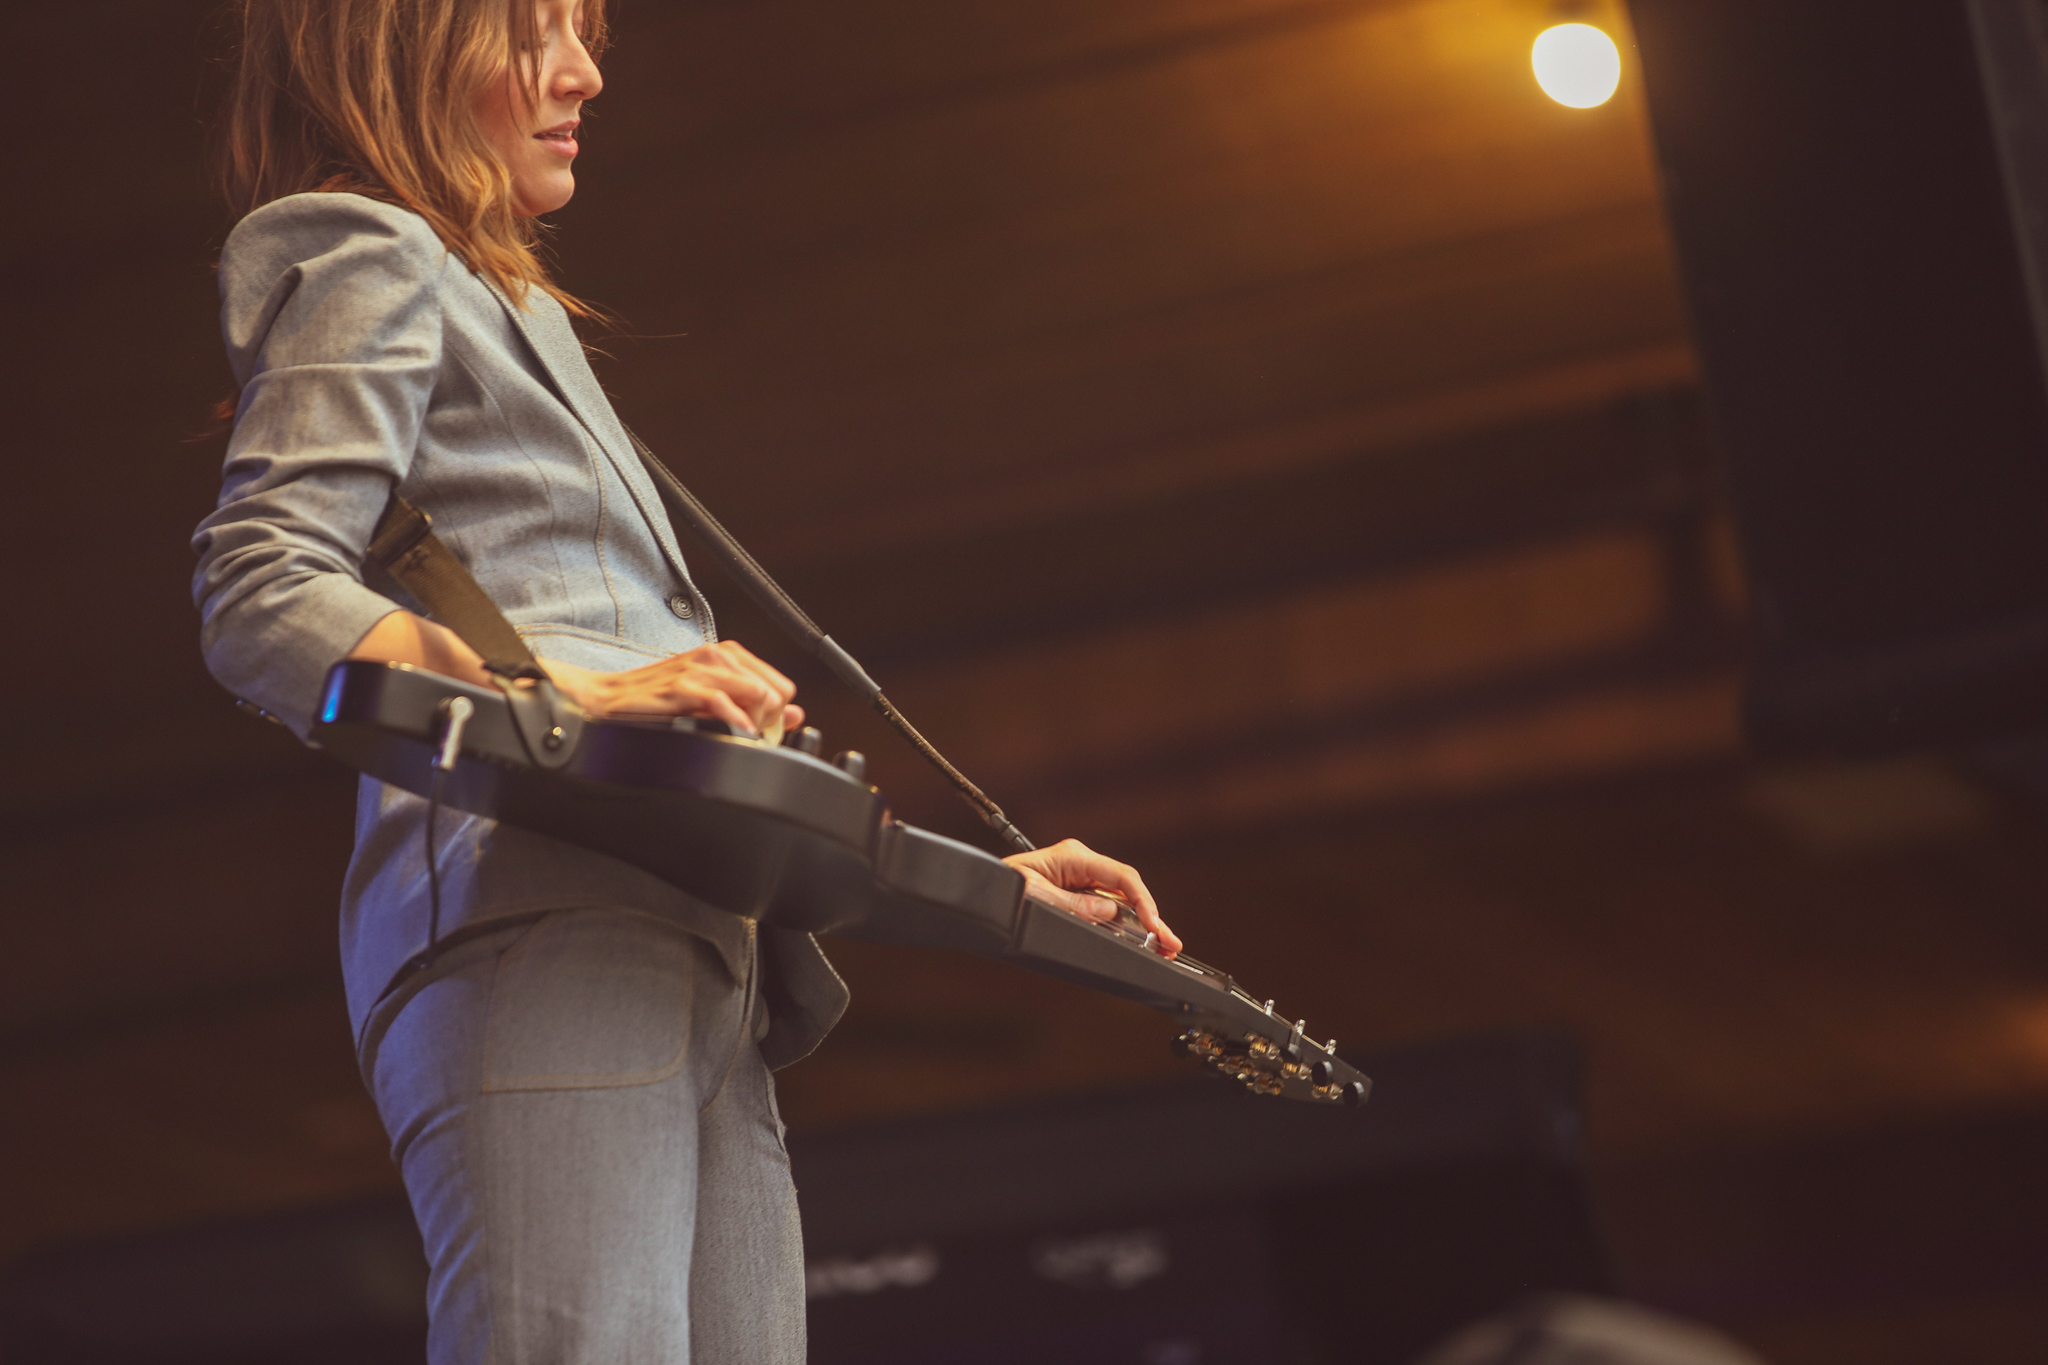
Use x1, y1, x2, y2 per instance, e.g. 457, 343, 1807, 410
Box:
219, 0, 606, 317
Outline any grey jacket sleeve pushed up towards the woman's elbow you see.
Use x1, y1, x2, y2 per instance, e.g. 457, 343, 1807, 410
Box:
193, 194, 449, 735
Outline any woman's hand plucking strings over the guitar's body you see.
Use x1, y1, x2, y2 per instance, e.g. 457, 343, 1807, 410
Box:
541, 641, 803, 735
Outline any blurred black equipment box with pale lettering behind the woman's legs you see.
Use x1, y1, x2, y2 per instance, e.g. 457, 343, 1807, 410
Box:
788, 1031, 1614, 1365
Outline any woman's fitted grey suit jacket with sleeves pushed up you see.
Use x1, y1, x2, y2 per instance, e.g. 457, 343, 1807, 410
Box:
193, 194, 846, 1066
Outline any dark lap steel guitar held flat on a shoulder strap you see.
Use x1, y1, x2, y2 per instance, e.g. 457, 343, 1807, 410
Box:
311, 661, 1370, 1105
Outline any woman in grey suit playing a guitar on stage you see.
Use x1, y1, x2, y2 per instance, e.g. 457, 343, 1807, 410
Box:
195, 0, 1180, 1363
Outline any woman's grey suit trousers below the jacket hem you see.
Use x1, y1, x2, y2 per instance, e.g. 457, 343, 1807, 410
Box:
365, 911, 805, 1365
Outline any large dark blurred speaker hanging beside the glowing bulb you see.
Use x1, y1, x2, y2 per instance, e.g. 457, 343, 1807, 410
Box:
1630, 0, 2048, 755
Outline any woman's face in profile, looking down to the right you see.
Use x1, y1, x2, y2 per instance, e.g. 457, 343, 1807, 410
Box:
477, 0, 604, 217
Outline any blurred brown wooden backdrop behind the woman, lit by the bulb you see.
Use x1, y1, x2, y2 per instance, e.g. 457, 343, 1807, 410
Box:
12, 0, 2048, 1365
